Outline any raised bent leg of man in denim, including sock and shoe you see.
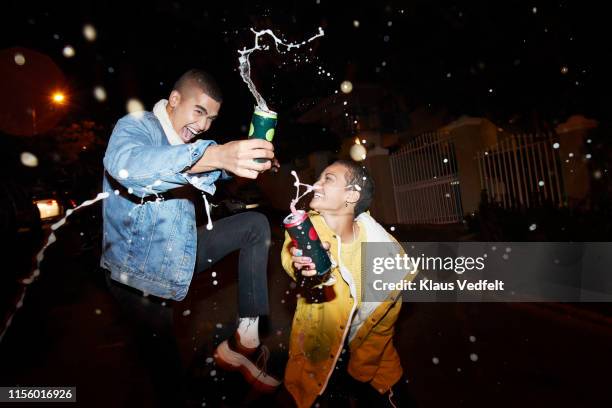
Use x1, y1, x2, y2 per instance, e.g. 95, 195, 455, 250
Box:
196, 212, 280, 391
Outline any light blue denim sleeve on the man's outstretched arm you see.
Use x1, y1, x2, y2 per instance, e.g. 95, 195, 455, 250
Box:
104, 116, 221, 197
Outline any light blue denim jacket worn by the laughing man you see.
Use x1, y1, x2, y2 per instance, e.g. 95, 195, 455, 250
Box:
100, 112, 227, 300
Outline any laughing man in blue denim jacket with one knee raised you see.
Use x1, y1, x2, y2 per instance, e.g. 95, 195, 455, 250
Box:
100, 69, 279, 404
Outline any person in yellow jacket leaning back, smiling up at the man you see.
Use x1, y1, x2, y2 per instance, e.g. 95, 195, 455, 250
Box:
281, 161, 410, 408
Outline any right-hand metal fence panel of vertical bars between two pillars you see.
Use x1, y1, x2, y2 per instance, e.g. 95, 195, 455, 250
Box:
477, 133, 564, 208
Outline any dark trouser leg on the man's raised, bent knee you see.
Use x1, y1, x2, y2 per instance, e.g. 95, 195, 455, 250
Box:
195, 212, 270, 317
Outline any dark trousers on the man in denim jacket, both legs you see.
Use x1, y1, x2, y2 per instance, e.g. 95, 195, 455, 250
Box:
106, 212, 270, 407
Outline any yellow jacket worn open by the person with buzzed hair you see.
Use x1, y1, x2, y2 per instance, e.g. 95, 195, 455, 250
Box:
281, 211, 414, 408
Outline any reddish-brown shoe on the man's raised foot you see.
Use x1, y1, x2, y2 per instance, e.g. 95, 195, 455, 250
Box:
214, 333, 281, 393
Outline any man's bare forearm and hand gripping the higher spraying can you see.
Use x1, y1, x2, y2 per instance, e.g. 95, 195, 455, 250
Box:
187, 139, 274, 179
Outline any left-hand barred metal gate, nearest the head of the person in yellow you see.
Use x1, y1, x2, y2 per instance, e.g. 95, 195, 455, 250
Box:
390, 132, 463, 224
